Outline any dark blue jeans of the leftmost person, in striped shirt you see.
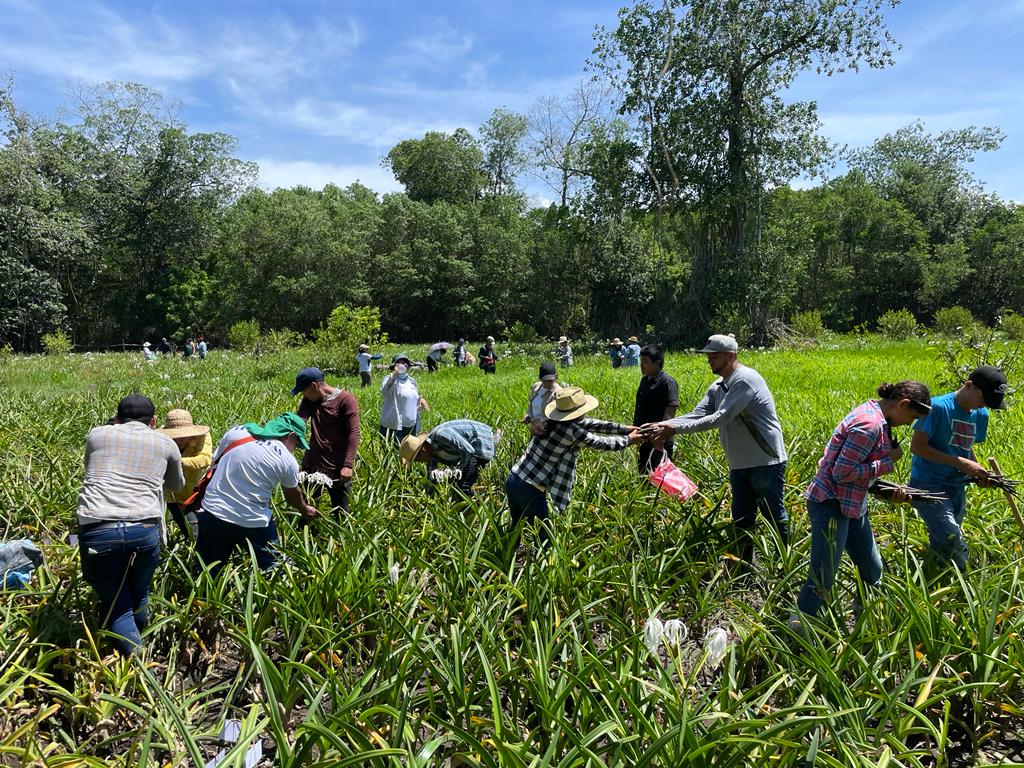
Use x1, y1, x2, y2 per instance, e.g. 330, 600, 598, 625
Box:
78, 522, 160, 655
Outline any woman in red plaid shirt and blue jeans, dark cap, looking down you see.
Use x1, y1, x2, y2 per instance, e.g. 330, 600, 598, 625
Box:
791, 381, 932, 626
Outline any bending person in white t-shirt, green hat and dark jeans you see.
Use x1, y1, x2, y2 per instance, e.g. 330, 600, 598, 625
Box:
196, 414, 319, 571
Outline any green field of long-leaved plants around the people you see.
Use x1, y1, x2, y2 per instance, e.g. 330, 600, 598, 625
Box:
0, 340, 1024, 768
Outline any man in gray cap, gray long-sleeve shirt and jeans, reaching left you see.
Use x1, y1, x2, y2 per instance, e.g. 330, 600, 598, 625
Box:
648, 334, 790, 562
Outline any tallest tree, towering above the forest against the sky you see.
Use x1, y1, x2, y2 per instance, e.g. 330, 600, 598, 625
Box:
594, 0, 897, 339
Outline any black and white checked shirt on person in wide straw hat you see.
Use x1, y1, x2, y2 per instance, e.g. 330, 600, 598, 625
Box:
512, 419, 633, 510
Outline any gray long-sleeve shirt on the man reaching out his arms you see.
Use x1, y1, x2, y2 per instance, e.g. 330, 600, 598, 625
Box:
669, 365, 786, 469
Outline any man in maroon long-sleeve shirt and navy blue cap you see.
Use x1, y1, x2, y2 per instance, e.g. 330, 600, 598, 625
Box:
292, 368, 359, 514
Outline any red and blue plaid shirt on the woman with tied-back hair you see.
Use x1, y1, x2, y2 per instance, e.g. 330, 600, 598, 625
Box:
807, 400, 893, 519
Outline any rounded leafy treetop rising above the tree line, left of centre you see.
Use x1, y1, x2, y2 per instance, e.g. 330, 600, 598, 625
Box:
383, 128, 486, 203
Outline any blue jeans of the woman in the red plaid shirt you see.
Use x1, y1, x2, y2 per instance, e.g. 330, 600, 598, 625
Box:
797, 499, 882, 616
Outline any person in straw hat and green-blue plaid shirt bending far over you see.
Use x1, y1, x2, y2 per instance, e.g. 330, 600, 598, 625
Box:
398, 419, 495, 498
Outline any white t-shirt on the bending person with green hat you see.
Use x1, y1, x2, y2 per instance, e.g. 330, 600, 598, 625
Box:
203, 426, 299, 528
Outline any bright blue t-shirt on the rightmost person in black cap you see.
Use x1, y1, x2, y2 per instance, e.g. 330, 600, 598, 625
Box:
910, 392, 988, 485
